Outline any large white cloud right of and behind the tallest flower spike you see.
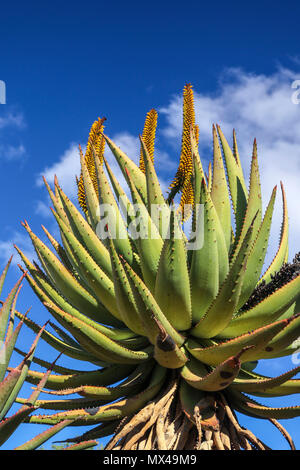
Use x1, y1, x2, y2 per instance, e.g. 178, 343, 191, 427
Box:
160, 68, 300, 264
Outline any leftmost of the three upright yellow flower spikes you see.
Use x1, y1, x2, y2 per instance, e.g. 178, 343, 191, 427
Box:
77, 117, 106, 213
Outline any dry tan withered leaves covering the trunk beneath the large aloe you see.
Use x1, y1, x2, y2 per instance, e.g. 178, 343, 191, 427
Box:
105, 378, 294, 450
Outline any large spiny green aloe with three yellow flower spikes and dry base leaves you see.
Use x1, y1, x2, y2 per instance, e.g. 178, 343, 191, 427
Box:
12, 85, 300, 450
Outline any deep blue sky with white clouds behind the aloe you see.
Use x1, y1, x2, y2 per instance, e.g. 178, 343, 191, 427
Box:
0, 0, 300, 448
